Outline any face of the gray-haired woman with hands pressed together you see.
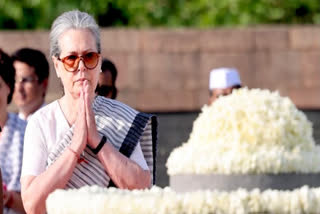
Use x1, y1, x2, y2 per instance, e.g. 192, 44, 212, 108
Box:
53, 29, 101, 98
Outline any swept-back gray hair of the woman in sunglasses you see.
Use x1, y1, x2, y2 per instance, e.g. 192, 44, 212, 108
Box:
50, 10, 101, 56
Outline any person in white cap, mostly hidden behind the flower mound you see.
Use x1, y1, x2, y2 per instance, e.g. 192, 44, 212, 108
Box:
208, 68, 241, 105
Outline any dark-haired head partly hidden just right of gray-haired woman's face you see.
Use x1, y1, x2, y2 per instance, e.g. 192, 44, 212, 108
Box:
96, 58, 118, 99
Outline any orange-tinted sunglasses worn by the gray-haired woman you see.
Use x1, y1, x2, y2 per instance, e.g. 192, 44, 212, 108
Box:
58, 52, 100, 72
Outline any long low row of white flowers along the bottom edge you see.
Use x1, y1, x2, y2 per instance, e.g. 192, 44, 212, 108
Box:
46, 186, 320, 214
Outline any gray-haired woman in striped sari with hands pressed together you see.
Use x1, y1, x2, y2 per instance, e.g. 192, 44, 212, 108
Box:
21, 11, 155, 213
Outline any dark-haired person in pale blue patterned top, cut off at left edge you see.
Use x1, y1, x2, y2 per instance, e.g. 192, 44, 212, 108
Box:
0, 49, 26, 213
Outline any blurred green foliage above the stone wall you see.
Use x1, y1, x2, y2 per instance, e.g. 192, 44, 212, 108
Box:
0, 0, 320, 29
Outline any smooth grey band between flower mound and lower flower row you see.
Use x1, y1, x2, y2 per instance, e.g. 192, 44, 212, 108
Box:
170, 173, 320, 192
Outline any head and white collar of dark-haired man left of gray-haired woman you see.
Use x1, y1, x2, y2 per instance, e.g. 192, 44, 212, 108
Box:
12, 48, 49, 120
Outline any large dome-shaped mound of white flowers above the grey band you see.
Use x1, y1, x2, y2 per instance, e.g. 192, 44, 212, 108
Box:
167, 88, 320, 175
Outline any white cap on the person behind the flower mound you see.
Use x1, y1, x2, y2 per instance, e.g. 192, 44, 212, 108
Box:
209, 68, 241, 90
